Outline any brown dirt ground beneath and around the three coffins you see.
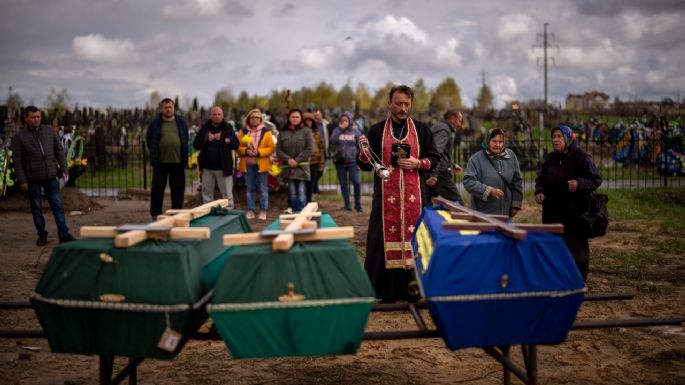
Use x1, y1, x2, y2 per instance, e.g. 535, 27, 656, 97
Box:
0, 185, 685, 385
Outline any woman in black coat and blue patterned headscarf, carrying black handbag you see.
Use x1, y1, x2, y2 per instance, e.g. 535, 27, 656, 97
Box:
535, 125, 602, 279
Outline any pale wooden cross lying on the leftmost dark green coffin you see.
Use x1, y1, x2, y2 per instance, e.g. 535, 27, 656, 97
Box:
80, 199, 228, 248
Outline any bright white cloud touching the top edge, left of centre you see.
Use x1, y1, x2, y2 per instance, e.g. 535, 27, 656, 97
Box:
161, 0, 254, 20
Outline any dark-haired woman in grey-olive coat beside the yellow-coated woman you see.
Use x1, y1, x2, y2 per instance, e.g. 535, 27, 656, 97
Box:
276, 109, 313, 212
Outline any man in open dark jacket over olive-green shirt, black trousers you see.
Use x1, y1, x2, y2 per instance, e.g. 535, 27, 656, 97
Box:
146, 98, 188, 220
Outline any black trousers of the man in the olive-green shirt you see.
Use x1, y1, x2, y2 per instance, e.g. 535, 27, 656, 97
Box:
150, 163, 186, 218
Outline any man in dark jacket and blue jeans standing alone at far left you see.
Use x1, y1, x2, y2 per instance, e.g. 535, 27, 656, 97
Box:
12, 106, 74, 246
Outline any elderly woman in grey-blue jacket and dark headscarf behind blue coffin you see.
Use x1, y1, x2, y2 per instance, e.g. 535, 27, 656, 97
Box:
464, 128, 523, 217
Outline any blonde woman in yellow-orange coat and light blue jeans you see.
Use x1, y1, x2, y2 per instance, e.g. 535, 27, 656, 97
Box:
238, 108, 276, 220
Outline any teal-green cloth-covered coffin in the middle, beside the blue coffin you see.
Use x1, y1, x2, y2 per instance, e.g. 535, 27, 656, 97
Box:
208, 214, 375, 358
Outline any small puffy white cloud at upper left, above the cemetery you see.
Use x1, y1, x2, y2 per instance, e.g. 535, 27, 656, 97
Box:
71, 34, 140, 64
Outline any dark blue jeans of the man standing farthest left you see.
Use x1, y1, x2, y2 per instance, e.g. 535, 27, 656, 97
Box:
28, 178, 69, 240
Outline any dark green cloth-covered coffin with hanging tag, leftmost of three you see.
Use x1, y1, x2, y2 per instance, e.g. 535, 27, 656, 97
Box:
31, 211, 251, 358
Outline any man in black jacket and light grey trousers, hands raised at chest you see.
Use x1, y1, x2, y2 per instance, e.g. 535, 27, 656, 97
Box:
193, 106, 238, 209
